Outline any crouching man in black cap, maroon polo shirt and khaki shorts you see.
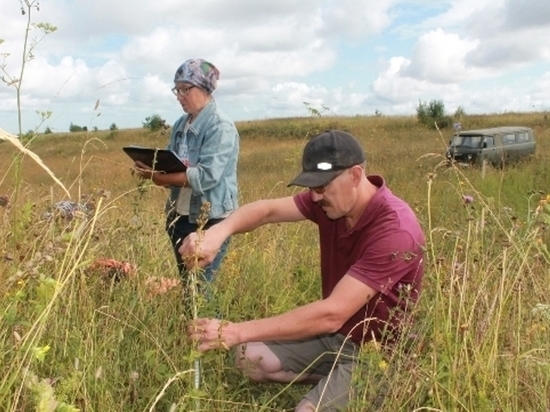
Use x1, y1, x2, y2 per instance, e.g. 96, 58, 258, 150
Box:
179, 131, 425, 412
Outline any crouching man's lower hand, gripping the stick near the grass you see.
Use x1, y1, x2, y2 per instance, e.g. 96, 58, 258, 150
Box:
187, 318, 239, 352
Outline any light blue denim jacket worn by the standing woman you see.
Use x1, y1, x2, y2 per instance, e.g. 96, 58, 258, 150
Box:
166, 99, 239, 223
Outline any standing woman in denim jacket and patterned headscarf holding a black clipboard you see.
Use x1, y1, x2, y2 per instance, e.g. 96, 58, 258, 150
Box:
136, 59, 239, 282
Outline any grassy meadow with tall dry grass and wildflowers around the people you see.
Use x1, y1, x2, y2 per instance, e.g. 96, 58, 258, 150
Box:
0, 113, 550, 412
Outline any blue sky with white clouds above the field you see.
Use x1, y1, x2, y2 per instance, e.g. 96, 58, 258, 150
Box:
0, 0, 550, 133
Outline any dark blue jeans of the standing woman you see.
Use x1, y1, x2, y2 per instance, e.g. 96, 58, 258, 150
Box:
166, 213, 230, 282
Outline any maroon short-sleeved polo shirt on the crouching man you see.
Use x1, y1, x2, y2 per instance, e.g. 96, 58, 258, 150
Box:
294, 175, 425, 343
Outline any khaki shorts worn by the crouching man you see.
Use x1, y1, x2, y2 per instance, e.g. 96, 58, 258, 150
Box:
264, 334, 359, 412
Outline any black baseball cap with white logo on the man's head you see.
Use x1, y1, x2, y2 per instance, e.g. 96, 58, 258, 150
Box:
287, 130, 365, 187
